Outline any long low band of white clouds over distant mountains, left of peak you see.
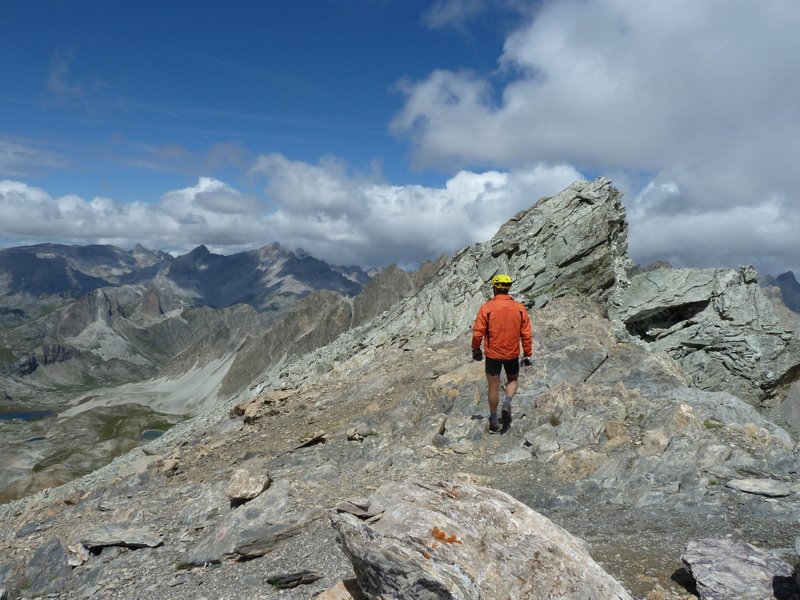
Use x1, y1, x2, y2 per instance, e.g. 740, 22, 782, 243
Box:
0, 154, 581, 266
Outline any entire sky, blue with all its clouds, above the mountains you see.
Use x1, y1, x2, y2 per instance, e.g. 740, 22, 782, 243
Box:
0, 0, 800, 273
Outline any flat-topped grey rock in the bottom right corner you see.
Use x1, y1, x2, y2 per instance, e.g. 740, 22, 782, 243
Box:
681, 538, 800, 600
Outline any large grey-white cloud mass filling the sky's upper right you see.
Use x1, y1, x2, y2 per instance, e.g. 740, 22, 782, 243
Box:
392, 0, 800, 270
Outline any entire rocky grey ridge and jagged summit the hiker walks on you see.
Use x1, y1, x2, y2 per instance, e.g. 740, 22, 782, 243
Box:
0, 178, 800, 600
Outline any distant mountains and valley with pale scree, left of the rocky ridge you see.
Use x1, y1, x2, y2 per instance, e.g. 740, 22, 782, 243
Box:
0, 244, 438, 498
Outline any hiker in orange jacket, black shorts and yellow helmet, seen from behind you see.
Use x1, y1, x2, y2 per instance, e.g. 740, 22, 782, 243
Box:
472, 274, 533, 433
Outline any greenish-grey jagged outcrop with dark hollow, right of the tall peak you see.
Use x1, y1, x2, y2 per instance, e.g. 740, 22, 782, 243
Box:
609, 267, 800, 408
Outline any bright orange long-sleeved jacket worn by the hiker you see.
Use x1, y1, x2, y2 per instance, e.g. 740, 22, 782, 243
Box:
472, 294, 533, 360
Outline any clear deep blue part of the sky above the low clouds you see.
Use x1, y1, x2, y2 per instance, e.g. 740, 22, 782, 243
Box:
0, 0, 504, 201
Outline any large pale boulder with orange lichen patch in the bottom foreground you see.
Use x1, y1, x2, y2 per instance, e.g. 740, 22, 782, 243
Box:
330, 480, 631, 600
